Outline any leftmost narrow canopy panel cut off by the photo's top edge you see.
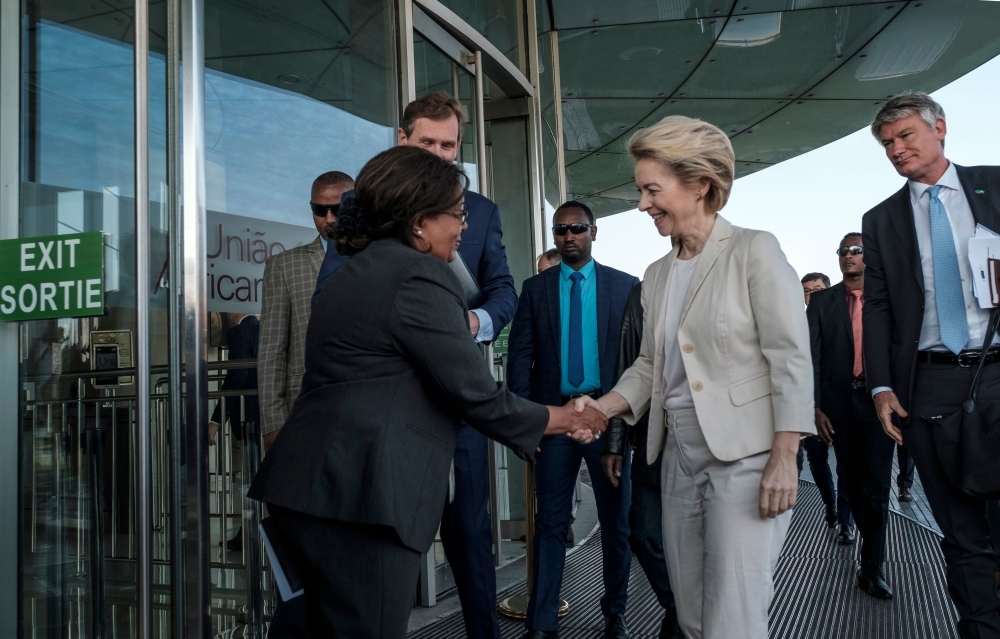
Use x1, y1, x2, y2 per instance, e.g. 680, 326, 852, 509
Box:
552, 0, 736, 29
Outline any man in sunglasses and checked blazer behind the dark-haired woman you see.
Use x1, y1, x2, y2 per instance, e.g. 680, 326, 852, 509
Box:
257, 171, 354, 449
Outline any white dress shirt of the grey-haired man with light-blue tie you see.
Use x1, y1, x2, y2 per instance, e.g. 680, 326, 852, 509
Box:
907, 159, 998, 351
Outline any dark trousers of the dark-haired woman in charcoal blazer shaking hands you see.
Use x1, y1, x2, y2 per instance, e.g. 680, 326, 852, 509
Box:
269, 506, 422, 639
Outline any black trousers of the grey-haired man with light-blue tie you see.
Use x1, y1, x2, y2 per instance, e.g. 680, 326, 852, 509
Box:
902, 364, 1000, 639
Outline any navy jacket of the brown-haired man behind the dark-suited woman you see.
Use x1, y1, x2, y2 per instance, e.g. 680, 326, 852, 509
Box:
313, 191, 517, 337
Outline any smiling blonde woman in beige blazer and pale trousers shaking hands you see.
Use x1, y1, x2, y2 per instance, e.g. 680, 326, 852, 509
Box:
580, 116, 815, 639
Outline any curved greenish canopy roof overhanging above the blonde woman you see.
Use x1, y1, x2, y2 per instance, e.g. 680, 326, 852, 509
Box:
540, 0, 1000, 215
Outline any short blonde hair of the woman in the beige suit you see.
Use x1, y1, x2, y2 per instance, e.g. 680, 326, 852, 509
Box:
628, 115, 736, 213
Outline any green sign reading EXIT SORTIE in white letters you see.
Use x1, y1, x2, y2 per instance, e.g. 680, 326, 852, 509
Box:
0, 232, 104, 322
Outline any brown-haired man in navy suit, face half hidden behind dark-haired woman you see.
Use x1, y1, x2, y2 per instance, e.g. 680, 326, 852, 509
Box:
313, 93, 520, 639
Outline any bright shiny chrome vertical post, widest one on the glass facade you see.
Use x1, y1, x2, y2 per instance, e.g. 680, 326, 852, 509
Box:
183, 0, 212, 639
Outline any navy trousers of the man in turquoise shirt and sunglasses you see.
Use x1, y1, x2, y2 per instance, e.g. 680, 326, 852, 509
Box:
525, 435, 632, 631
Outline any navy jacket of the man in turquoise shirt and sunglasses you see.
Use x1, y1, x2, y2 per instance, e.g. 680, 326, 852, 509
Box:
507, 262, 639, 406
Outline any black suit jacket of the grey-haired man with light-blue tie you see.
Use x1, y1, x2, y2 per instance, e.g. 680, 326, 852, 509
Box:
861, 164, 1000, 418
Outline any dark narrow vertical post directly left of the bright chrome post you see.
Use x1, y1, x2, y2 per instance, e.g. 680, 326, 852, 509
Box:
166, 0, 187, 637
